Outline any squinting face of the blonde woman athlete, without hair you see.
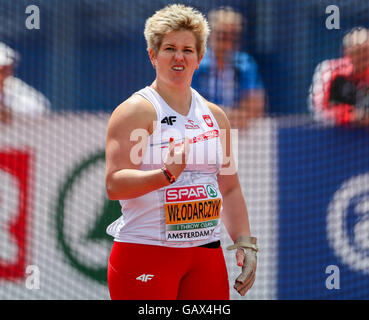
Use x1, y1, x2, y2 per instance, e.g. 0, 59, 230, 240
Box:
149, 30, 201, 85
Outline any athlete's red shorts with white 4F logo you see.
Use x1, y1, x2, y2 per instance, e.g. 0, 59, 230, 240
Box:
108, 242, 229, 300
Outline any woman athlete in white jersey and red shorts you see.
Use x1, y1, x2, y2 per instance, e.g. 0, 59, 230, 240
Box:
106, 5, 258, 300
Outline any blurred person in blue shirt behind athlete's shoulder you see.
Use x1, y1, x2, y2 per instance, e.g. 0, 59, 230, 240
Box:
192, 7, 265, 128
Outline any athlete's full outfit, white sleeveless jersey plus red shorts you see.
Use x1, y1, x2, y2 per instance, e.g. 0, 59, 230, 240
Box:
107, 87, 229, 300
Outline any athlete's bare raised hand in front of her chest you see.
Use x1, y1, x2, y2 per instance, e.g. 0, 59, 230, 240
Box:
164, 137, 190, 178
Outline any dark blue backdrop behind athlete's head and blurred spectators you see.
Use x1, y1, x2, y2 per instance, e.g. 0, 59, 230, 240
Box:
0, 0, 369, 115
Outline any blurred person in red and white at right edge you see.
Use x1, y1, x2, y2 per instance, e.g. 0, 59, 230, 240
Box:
309, 27, 369, 126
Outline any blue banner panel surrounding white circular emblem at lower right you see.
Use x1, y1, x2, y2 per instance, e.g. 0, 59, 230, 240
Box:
278, 126, 369, 299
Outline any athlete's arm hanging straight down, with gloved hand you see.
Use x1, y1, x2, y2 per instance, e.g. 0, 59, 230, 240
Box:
207, 102, 257, 295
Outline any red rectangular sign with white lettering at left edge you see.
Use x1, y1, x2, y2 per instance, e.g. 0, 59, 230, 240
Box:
0, 150, 34, 281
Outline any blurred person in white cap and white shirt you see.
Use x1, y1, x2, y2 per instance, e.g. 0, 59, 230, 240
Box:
0, 42, 50, 123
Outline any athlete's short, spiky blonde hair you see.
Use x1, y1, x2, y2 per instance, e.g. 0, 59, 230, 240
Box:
144, 4, 210, 57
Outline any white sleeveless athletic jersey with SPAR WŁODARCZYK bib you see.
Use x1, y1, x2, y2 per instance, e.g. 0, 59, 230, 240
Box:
107, 87, 223, 247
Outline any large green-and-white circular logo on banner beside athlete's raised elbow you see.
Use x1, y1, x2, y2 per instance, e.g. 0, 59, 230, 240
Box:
52, 151, 121, 284
